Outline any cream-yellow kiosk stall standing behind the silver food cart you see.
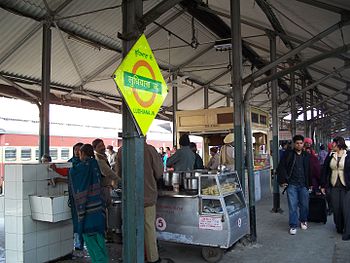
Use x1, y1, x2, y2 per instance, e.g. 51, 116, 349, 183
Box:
176, 107, 271, 201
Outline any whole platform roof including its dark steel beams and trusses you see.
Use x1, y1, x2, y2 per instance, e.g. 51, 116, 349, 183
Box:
0, 0, 350, 138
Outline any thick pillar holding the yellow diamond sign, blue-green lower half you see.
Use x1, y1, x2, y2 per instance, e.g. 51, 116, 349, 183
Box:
122, 0, 145, 263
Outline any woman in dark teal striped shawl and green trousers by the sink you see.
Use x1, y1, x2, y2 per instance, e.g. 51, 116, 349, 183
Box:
69, 144, 108, 263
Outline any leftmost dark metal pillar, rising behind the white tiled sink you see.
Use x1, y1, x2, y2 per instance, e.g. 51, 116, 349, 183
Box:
39, 21, 51, 160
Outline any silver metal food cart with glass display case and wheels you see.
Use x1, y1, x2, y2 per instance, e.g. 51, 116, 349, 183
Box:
156, 170, 248, 262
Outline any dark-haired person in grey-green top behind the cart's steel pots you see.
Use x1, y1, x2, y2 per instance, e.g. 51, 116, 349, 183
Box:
166, 134, 196, 172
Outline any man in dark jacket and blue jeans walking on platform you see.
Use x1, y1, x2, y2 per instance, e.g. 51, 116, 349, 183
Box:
277, 135, 312, 235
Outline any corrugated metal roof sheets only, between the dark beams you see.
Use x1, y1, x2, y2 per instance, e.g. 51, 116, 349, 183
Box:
0, 0, 350, 132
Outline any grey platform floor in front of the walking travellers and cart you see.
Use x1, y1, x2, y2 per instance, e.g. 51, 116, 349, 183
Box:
0, 196, 350, 263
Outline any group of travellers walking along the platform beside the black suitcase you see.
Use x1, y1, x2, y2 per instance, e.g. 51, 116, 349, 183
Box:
277, 135, 350, 240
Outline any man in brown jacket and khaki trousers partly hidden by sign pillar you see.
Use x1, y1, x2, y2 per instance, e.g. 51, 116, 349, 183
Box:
118, 141, 164, 263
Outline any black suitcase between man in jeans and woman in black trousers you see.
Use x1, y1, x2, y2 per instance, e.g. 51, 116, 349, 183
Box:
308, 193, 327, 224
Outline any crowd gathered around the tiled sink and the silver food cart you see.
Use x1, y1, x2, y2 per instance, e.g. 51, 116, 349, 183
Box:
41, 134, 234, 263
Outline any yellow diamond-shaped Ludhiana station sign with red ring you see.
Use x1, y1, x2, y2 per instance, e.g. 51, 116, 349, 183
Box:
114, 34, 168, 135
